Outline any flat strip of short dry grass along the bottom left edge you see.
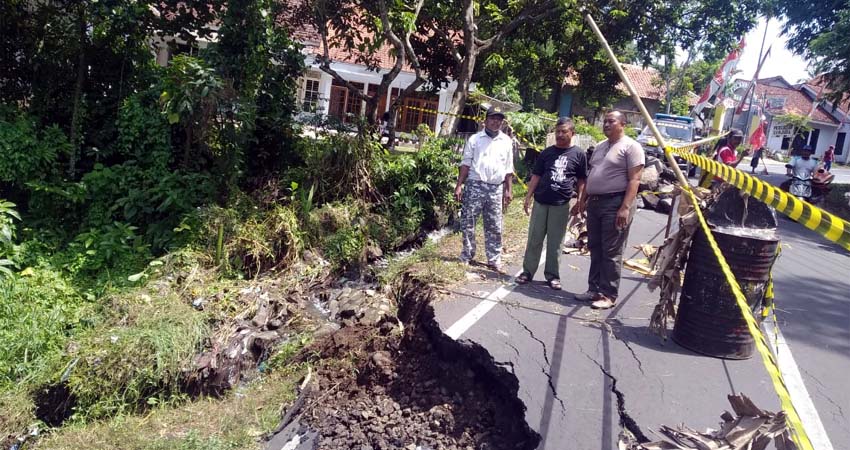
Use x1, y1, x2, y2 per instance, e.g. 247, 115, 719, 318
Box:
35, 366, 306, 450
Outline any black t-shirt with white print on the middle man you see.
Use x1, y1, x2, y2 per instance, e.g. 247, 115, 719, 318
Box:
531, 145, 587, 206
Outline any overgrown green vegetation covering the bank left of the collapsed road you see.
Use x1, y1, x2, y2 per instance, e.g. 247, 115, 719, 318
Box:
0, 2, 459, 449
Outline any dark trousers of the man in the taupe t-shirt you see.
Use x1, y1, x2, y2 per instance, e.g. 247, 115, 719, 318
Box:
587, 194, 634, 300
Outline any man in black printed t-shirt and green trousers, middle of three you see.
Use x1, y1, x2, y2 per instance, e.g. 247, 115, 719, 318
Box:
516, 117, 587, 290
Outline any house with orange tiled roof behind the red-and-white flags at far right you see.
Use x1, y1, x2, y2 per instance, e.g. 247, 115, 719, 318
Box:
733, 76, 850, 162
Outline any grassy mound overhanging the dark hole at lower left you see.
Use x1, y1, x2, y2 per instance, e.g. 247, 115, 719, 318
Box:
61, 293, 210, 420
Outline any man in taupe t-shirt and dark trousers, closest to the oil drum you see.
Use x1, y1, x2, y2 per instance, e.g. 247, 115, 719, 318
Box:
576, 111, 646, 309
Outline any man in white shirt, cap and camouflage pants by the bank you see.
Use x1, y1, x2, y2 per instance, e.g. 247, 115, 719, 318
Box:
455, 107, 514, 273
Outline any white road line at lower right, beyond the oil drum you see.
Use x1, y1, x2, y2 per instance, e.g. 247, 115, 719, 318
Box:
762, 320, 834, 450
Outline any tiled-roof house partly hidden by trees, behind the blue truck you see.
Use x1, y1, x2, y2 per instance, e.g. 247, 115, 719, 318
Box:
558, 64, 698, 128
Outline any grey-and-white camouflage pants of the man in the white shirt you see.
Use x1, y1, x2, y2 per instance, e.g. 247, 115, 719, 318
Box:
460, 180, 502, 264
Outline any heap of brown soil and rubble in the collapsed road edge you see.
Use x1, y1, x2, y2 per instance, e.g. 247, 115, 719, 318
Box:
269, 278, 540, 450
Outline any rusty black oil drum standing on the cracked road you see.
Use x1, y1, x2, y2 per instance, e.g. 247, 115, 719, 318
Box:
673, 230, 779, 359
